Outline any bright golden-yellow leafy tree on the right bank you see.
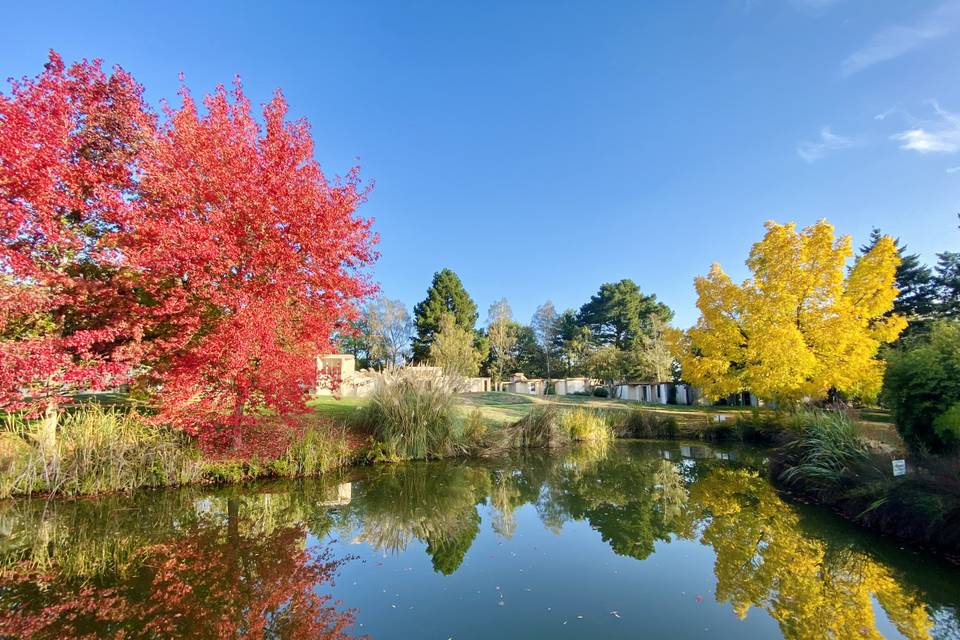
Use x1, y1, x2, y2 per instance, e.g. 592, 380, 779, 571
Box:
680, 220, 906, 402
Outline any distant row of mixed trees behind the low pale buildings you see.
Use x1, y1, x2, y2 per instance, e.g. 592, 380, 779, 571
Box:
340, 269, 676, 386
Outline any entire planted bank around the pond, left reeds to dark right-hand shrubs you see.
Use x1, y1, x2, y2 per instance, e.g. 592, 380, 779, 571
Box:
0, 378, 960, 553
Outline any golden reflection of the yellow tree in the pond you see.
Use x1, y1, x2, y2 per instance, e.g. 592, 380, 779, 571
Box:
690, 469, 932, 639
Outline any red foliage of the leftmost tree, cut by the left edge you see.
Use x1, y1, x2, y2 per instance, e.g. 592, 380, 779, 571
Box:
0, 53, 154, 409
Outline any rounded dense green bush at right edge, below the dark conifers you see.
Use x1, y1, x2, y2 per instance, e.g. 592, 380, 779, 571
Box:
883, 320, 960, 452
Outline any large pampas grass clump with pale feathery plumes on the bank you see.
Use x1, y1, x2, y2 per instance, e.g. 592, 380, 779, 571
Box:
362, 367, 455, 460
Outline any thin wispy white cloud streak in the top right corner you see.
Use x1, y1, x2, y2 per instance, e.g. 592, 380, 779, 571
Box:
841, 0, 960, 76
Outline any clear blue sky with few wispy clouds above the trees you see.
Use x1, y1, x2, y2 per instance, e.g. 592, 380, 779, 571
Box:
0, 0, 960, 326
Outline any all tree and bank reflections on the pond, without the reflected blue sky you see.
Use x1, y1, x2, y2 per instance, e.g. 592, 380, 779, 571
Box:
0, 444, 958, 639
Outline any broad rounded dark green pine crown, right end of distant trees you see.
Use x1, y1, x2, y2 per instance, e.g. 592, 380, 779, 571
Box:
578, 279, 673, 350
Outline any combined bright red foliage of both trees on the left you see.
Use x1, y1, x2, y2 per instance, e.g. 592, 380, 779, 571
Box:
0, 54, 376, 446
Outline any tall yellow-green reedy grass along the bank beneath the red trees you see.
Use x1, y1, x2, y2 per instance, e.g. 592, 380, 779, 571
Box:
0, 403, 356, 498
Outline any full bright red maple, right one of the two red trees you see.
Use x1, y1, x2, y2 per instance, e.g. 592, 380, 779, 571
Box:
129, 82, 376, 445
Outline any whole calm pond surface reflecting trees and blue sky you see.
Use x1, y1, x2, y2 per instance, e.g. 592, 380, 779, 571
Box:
0, 442, 960, 640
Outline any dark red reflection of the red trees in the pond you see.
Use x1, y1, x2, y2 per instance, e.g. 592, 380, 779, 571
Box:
0, 527, 353, 639
